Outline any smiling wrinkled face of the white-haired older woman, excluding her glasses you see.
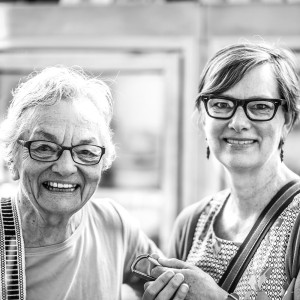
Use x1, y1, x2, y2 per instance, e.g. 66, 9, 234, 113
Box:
16, 98, 104, 214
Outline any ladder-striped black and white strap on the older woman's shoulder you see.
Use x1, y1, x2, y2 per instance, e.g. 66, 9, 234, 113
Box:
0, 198, 26, 300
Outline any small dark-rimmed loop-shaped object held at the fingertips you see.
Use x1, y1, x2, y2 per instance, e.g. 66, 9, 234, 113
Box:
131, 254, 161, 281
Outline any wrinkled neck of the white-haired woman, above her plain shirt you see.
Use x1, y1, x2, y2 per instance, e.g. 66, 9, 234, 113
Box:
17, 193, 82, 248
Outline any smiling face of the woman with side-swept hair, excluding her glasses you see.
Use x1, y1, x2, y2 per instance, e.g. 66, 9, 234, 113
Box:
201, 64, 291, 175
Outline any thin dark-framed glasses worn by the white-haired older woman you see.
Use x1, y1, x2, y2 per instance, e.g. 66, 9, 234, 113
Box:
18, 140, 105, 166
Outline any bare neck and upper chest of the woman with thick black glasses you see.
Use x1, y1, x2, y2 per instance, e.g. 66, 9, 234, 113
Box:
214, 163, 299, 243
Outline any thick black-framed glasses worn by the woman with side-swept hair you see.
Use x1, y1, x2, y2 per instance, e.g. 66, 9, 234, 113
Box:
197, 94, 287, 121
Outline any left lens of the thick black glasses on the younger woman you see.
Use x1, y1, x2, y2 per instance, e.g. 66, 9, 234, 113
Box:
207, 98, 235, 118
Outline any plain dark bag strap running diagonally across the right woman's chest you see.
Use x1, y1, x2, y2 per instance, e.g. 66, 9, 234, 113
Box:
219, 181, 300, 293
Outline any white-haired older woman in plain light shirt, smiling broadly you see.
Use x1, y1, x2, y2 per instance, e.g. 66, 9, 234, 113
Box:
0, 67, 157, 300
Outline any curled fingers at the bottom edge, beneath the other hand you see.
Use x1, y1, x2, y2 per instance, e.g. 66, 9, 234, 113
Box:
143, 271, 188, 300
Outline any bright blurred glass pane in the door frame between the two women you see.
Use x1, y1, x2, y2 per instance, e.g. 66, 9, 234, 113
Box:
101, 72, 164, 188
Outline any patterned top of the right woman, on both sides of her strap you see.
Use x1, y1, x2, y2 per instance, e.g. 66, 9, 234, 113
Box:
187, 194, 300, 300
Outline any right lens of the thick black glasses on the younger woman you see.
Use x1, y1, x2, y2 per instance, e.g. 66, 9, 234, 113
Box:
247, 100, 275, 120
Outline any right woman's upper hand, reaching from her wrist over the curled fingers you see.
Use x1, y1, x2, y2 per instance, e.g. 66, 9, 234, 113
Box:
150, 256, 228, 300
